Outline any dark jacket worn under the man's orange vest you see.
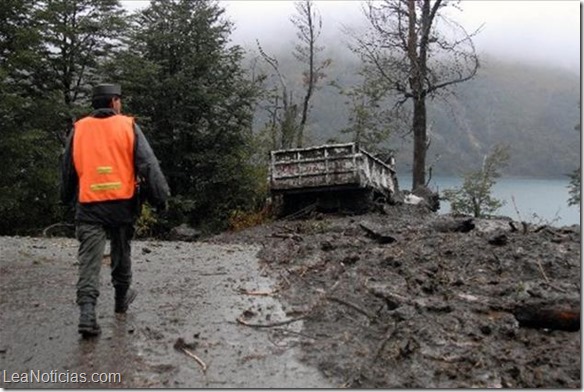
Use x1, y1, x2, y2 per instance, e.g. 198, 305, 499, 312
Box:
61, 109, 170, 225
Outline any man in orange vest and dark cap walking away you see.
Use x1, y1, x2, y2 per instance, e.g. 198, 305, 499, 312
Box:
61, 84, 170, 337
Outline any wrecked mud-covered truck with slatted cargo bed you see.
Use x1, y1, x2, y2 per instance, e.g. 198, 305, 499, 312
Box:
269, 143, 399, 214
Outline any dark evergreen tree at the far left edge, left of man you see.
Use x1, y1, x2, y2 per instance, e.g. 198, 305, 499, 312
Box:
0, 0, 59, 235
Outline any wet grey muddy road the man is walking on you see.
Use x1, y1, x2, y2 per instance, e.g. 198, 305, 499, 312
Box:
0, 237, 331, 389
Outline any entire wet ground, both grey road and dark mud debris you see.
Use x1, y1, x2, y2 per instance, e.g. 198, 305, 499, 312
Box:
0, 206, 581, 388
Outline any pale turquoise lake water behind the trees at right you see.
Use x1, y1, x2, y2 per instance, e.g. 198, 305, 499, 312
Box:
398, 176, 580, 226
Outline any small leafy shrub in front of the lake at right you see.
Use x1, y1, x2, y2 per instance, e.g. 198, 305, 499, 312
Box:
444, 145, 509, 218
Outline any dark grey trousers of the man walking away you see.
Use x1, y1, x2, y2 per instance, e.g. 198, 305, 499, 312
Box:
75, 222, 134, 304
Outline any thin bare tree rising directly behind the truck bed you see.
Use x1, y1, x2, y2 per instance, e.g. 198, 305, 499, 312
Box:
290, 0, 331, 147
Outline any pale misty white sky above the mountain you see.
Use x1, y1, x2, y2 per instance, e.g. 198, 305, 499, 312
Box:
122, 0, 581, 72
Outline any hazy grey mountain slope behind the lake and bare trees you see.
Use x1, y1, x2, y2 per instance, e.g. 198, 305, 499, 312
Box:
260, 56, 580, 177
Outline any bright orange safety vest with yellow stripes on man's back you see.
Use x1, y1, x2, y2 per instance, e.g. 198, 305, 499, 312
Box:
73, 115, 136, 203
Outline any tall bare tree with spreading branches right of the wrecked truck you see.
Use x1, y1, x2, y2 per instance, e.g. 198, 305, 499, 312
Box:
353, 0, 479, 189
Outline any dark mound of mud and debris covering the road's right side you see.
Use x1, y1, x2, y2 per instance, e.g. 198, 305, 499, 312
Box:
214, 203, 581, 388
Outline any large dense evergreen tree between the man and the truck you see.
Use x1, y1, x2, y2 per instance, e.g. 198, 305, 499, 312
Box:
108, 0, 265, 231
